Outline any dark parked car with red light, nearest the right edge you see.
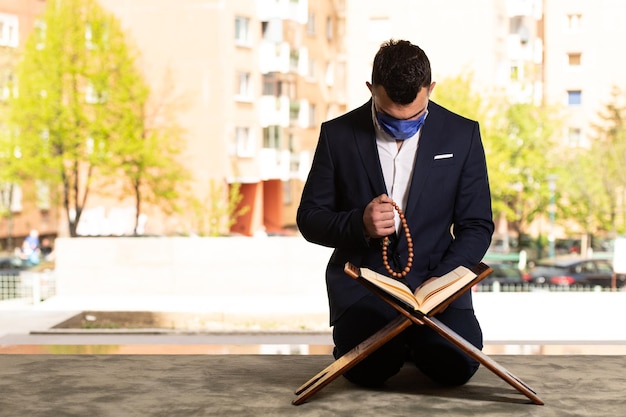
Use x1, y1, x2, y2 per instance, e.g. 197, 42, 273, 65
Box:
528, 257, 624, 288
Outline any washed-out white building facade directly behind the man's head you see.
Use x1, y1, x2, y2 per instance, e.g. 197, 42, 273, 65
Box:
345, 0, 509, 108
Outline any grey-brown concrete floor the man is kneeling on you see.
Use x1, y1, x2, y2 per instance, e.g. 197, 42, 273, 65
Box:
0, 354, 626, 417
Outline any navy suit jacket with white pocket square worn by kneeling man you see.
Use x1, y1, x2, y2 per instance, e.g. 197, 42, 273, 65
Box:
297, 100, 494, 325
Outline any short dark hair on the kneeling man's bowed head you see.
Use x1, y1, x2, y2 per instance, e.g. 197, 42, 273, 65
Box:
372, 39, 431, 104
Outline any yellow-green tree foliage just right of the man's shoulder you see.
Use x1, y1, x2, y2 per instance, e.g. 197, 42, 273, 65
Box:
434, 74, 561, 239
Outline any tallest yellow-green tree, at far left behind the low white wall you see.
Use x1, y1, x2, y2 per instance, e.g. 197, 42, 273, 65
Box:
10, 0, 136, 236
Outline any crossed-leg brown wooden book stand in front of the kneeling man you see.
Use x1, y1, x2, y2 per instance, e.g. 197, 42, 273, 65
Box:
292, 268, 544, 405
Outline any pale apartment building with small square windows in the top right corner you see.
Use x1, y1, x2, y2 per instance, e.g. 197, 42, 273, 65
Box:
543, 0, 626, 147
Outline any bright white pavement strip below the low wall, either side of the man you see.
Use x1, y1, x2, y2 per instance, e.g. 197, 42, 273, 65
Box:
0, 292, 626, 345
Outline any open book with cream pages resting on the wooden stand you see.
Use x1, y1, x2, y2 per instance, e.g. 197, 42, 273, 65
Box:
344, 262, 492, 315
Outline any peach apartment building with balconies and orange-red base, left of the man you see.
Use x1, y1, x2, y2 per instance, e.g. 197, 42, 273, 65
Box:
94, 0, 345, 235
